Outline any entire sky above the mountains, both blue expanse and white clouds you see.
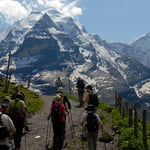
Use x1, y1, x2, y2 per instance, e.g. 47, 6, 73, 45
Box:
0, 0, 150, 42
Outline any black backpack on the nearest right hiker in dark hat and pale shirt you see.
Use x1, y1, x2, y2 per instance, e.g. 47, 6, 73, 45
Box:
86, 112, 99, 132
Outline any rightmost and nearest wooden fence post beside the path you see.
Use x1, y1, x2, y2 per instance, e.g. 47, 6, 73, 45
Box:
142, 110, 148, 150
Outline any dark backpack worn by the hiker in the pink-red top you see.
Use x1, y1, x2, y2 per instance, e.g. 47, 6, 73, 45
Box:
52, 103, 62, 122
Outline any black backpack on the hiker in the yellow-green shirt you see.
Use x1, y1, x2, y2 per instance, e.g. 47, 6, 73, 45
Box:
8, 101, 22, 126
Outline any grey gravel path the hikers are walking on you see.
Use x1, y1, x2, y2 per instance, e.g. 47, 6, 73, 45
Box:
21, 96, 117, 150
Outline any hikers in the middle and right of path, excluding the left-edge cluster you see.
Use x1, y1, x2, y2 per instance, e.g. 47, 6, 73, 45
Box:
48, 77, 103, 150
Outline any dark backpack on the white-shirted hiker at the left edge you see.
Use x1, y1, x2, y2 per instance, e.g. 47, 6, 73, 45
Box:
0, 115, 10, 140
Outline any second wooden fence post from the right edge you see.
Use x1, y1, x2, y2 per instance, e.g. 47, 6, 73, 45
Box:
134, 103, 138, 137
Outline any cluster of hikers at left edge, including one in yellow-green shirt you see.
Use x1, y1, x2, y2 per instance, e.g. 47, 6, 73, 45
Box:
0, 86, 29, 150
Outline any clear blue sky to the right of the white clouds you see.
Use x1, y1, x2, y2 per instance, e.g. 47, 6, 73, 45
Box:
79, 0, 150, 42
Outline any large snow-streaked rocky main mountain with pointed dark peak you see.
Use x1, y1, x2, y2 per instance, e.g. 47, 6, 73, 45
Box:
0, 9, 150, 104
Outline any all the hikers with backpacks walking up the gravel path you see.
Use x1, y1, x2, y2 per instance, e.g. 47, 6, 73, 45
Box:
0, 77, 103, 150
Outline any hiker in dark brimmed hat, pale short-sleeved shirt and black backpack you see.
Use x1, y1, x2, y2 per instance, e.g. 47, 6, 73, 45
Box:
81, 104, 103, 150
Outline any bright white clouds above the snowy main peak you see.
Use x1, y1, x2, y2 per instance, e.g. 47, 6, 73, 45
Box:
0, 0, 82, 24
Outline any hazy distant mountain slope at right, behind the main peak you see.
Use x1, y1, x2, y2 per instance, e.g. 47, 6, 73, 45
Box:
108, 33, 150, 68
